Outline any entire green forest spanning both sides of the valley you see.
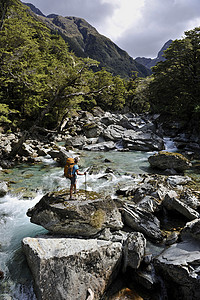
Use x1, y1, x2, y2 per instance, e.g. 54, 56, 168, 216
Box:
0, 0, 200, 131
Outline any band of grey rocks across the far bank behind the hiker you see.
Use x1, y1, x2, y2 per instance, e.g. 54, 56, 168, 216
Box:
0, 108, 200, 168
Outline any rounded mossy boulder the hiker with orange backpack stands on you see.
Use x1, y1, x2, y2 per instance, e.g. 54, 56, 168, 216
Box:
27, 190, 123, 237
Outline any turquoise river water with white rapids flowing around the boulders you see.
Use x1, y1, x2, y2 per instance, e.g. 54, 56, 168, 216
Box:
0, 145, 199, 300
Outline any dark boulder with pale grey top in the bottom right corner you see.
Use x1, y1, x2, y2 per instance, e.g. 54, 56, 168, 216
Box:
154, 240, 200, 300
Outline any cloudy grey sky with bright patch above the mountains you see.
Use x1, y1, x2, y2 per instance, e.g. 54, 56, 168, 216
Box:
23, 0, 200, 58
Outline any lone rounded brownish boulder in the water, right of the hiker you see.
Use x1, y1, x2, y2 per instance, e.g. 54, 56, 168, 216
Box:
148, 151, 191, 172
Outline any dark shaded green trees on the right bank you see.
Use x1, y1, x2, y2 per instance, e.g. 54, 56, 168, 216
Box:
150, 28, 200, 118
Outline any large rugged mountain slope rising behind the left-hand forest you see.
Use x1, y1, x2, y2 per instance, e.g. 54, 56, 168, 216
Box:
24, 3, 151, 78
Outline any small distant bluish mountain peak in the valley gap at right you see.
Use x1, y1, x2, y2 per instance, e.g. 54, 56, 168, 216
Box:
135, 40, 173, 69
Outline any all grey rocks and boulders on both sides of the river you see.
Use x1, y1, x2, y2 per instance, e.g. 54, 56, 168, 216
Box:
0, 110, 200, 300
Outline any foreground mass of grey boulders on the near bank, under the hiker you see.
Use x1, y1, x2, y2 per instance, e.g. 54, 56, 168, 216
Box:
22, 174, 200, 300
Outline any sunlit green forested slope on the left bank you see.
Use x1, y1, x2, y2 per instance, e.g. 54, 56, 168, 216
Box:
0, 0, 130, 128
